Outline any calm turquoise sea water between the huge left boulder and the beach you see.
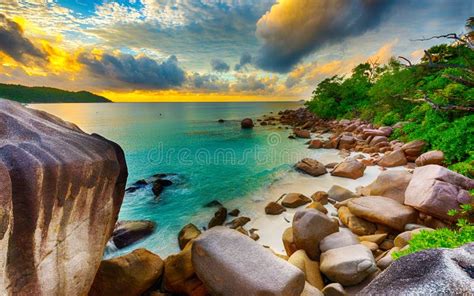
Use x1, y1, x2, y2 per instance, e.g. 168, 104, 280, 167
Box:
31, 102, 312, 257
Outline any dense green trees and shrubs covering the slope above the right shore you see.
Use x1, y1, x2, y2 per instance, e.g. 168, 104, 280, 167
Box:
307, 20, 474, 178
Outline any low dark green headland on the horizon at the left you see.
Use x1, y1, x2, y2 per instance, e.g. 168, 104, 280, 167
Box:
0, 83, 110, 103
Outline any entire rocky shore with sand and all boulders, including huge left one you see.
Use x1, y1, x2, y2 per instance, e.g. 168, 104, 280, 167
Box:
0, 101, 474, 296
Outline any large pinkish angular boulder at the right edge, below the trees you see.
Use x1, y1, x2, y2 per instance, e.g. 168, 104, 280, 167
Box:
405, 165, 474, 220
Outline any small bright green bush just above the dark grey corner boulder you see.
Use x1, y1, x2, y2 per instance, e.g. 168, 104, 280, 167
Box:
392, 225, 474, 259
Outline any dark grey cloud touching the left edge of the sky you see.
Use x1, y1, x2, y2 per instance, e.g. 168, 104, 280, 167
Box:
0, 13, 46, 63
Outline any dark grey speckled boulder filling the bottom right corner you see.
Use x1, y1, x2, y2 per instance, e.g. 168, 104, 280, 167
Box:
359, 243, 474, 295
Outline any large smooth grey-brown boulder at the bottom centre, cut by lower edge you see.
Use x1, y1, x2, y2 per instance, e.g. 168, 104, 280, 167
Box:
192, 227, 305, 296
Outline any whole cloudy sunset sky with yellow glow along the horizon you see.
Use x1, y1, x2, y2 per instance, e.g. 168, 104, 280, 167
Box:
0, 0, 474, 102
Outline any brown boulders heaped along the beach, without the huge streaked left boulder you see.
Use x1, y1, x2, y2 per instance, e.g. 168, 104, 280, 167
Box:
90, 109, 474, 296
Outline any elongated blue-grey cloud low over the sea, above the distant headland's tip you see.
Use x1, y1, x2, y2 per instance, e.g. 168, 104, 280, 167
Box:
79, 54, 186, 89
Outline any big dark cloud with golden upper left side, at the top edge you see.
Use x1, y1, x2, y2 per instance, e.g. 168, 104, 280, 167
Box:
256, 0, 396, 73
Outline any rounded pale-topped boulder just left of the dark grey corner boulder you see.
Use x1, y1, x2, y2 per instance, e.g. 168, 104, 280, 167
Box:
321, 244, 377, 286
